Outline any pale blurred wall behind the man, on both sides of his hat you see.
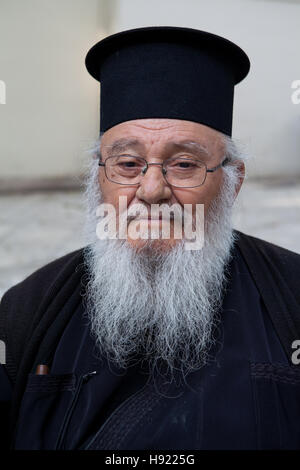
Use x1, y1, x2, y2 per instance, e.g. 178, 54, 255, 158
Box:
0, 0, 300, 189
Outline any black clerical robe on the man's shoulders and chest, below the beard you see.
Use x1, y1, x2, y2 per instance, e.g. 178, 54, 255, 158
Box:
0, 229, 300, 450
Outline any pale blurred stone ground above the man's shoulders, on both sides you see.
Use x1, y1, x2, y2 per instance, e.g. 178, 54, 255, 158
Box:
0, 180, 300, 298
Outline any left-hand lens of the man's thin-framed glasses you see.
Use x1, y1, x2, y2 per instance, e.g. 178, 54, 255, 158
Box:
105, 155, 146, 184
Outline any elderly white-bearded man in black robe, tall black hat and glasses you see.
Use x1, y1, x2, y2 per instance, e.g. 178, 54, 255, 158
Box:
0, 27, 300, 450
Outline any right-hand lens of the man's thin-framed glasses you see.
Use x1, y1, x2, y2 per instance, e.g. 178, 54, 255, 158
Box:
164, 157, 206, 188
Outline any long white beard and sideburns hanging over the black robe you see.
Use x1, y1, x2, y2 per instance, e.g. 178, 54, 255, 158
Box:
81, 160, 236, 375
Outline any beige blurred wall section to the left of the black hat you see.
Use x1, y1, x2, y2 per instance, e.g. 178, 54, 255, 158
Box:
0, 0, 114, 189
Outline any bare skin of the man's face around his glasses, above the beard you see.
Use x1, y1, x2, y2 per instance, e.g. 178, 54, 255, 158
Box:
99, 119, 243, 248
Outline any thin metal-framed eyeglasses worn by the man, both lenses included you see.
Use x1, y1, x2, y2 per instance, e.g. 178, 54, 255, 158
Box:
99, 154, 229, 188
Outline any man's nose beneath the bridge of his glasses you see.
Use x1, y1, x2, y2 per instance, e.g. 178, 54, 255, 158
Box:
136, 164, 172, 204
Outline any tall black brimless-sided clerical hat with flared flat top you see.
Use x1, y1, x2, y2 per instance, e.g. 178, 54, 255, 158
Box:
86, 26, 250, 135
